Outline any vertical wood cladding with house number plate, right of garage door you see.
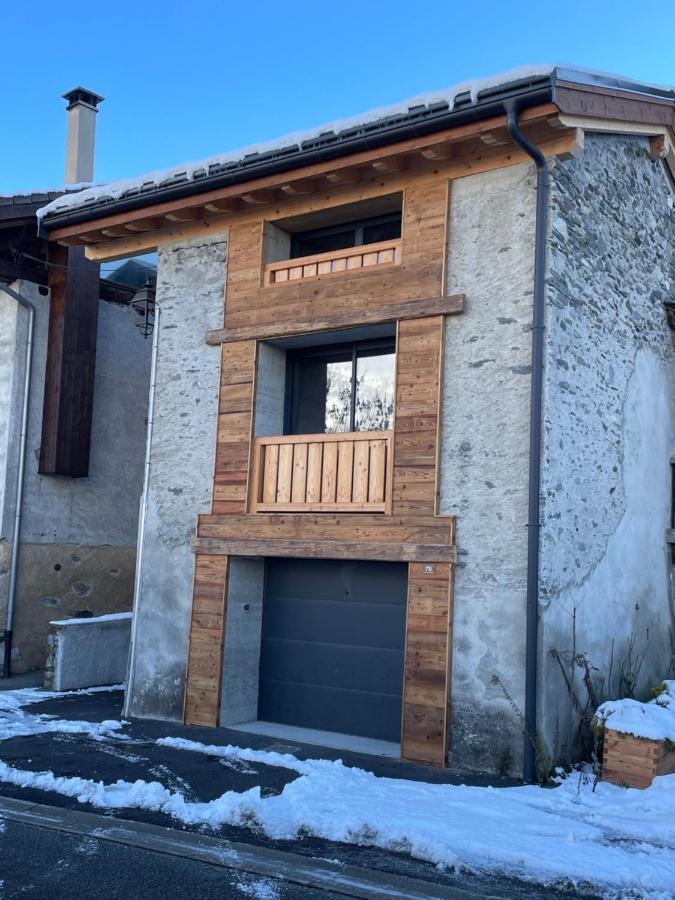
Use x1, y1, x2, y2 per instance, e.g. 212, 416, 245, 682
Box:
401, 563, 453, 766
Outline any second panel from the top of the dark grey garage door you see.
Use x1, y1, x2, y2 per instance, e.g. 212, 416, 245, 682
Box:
263, 595, 405, 649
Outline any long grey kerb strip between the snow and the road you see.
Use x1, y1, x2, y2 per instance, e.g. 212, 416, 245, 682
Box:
0, 797, 489, 900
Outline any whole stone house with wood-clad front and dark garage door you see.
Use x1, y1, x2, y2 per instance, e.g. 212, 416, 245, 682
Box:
41, 66, 675, 778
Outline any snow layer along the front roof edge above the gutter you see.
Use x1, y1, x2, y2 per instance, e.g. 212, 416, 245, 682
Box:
37, 65, 556, 219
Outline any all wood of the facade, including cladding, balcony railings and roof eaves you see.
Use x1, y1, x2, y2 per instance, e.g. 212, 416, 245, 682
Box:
45, 104, 580, 765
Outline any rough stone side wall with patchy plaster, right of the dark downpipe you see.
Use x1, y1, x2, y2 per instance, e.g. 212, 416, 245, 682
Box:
539, 135, 675, 759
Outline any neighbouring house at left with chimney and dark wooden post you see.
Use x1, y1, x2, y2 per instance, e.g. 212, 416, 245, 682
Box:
0, 89, 154, 675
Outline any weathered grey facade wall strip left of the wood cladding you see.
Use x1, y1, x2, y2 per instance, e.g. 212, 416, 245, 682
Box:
129, 234, 227, 719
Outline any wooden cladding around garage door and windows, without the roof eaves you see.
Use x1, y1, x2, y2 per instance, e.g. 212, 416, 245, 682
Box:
185, 169, 462, 765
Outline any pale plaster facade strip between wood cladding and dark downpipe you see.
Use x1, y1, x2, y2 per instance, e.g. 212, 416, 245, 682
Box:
440, 165, 535, 772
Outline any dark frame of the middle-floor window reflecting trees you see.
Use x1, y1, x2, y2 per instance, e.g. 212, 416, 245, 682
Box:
284, 335, 396, 435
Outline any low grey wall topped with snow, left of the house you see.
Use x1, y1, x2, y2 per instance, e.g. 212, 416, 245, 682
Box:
45, 612, 131, 691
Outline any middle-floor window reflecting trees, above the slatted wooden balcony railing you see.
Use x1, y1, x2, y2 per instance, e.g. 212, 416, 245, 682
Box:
286, 338, 395, 434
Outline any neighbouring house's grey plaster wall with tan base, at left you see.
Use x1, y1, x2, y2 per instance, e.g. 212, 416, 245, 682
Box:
0, 282, 150, 674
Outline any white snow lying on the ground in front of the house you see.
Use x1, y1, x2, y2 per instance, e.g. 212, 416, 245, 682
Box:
0, 691, 675, 900
